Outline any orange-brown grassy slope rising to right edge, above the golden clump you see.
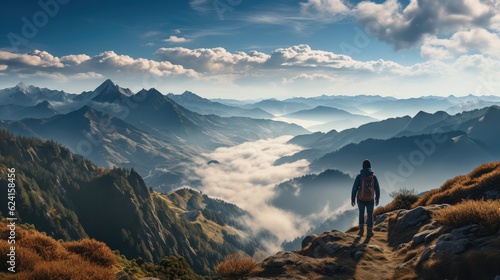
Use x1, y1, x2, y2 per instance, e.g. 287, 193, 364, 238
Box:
412, 162, 500, 207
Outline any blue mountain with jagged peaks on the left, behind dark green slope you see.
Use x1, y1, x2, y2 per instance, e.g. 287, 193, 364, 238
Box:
0, 80, 307, 191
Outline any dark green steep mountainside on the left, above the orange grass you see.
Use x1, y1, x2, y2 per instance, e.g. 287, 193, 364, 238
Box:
0, 132, 261, 273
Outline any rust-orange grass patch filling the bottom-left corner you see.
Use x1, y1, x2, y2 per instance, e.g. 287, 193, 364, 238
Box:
0, 222, 116, 280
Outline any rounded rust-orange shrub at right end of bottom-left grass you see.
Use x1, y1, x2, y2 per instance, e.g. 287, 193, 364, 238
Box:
64, 239, 116, 266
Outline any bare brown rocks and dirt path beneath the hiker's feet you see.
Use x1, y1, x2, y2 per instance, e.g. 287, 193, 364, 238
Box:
250, 204, 500, 279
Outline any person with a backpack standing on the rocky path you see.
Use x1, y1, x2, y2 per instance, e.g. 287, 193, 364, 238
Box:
351, 160, 380, 236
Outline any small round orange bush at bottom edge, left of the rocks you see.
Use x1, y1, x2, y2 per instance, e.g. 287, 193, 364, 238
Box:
214, 253, 257, 279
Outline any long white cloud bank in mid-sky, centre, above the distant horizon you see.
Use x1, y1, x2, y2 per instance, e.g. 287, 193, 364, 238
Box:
156, 44, 422, 75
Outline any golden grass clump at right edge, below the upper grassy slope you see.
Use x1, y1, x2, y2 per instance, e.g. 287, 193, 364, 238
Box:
433, 200, 500, 233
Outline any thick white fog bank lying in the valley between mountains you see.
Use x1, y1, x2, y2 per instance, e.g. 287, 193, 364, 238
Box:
189, 137, 310, 251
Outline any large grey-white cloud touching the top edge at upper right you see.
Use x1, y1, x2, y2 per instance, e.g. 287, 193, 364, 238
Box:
352, 0, 495, 49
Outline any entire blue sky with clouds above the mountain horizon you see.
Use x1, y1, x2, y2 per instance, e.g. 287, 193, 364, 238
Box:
0, 0, 500, 99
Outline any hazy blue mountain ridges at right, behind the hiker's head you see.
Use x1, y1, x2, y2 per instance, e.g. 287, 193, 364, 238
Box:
276, 106, 500, 191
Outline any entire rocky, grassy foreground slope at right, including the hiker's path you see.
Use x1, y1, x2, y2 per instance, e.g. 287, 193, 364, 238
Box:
243, 162, 500, 280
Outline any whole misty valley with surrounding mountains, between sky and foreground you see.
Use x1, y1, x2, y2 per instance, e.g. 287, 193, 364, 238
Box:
0, 80, 500, 274
